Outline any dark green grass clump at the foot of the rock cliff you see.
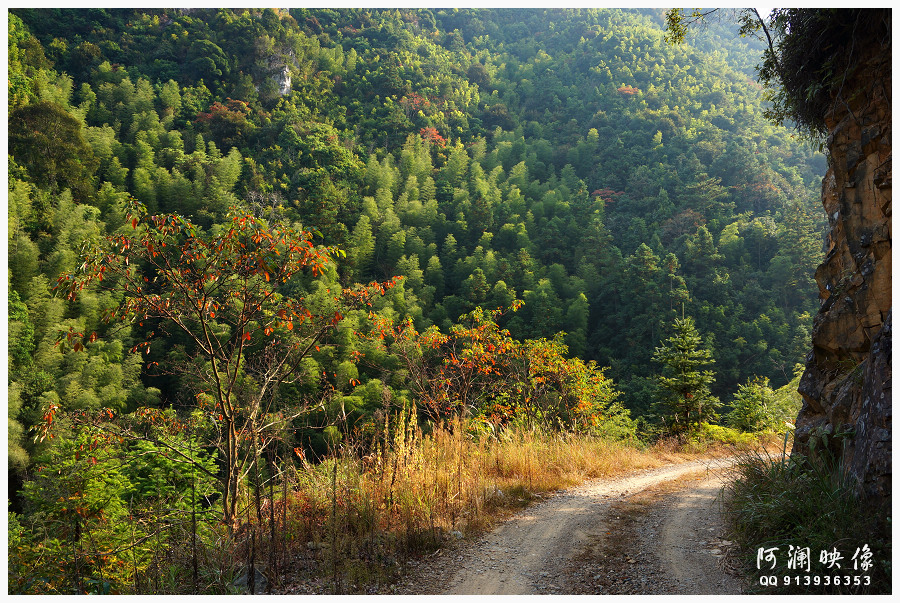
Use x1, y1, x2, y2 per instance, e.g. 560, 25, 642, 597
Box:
725, 437, 891, 594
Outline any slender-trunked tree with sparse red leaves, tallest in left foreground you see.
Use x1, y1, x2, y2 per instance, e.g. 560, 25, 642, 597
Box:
51, 201, 393, 528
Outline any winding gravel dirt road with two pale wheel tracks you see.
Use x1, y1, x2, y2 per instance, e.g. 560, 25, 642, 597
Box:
396, 459, 741, 595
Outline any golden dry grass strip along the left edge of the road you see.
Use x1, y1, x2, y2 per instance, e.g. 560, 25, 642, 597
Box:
155, 413, 772, 594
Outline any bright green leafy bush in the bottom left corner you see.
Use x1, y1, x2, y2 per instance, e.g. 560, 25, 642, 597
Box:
10, 430, 150, 594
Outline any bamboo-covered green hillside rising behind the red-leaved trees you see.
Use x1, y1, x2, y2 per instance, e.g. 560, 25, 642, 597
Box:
9, 3, 823, 452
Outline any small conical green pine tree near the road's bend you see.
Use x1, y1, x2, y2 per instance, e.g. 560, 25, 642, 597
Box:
653, 316, 720, 438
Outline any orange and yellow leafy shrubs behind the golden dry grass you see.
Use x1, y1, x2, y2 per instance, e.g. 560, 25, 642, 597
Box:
372, 301, 625, 430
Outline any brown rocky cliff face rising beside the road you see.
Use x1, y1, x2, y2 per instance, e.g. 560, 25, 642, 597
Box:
794, 46, 891, 500
